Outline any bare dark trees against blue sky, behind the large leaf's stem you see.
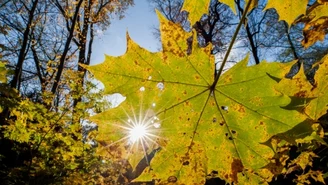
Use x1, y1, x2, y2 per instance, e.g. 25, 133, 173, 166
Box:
150, 0, 327, 64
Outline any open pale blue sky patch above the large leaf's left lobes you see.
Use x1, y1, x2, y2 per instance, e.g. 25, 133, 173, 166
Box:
91, 0, 160, 65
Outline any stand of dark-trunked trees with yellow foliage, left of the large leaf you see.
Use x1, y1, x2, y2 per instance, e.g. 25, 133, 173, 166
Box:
0, 0, 133, 184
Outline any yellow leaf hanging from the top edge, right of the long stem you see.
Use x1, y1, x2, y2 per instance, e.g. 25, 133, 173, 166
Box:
265, 0, 308, 25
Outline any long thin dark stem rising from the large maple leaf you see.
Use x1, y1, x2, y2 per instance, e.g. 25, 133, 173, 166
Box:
211, 0, 252, 90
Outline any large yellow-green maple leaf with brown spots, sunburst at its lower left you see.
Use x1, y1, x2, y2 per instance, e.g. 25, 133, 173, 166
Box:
88, 12, 307, 184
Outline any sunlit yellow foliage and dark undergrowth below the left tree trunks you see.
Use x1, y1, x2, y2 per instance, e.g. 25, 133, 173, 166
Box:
0, 64, 119, 184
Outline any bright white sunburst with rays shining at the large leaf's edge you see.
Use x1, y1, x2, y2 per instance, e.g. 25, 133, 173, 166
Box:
107, 98, 166, 166
